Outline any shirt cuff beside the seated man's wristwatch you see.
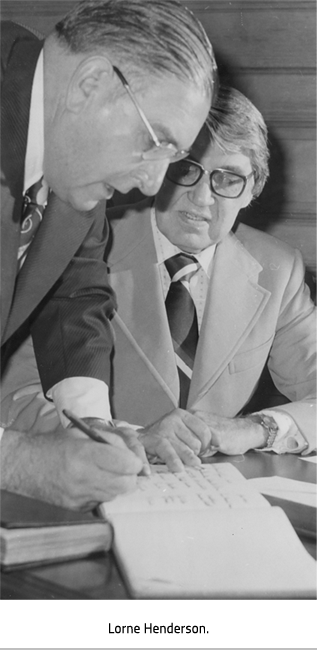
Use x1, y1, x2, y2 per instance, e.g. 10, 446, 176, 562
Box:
255, 409, 308, 455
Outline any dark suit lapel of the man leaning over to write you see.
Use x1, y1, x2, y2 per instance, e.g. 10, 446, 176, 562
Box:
5, 193, 96, 339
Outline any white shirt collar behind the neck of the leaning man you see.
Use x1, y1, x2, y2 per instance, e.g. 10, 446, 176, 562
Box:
24, 50, 44, 192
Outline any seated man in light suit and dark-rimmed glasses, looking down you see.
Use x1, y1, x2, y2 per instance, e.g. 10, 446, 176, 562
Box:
108, 88, 317, 455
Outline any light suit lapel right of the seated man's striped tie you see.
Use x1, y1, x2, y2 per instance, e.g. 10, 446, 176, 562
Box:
188, 233, 271, 406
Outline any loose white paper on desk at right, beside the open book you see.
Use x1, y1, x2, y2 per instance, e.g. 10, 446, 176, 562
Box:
249, 475, 317, 507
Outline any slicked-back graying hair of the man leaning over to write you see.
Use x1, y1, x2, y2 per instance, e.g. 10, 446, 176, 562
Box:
55, 0, 217, 93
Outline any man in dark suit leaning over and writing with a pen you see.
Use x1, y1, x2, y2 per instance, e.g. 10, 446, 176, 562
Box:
0, 0, 215, 506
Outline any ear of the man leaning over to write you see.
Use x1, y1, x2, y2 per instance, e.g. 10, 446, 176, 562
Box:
66, 55, 115, 113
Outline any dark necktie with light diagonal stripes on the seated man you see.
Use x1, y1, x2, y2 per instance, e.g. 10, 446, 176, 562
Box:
165, 253, 200, 408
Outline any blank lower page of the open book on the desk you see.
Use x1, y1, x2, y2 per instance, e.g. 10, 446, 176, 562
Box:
113, 507, 317, 599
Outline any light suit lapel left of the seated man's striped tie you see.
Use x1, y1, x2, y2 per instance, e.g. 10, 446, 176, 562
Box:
110, 208, 179, 406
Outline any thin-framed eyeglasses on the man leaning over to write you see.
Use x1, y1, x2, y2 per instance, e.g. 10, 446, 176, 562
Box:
112, 66, 189, 162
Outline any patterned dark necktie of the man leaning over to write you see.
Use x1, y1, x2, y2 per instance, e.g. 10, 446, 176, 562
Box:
19, 177, 48, 257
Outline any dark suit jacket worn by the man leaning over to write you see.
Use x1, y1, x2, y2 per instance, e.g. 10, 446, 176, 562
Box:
0, 22, 114, 391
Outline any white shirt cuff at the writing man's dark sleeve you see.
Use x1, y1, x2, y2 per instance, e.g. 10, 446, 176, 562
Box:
47, 377, 111, 428
